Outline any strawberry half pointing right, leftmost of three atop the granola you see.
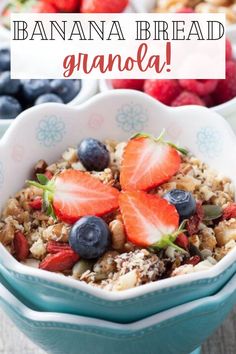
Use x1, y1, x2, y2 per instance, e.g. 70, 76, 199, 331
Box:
28, 169, 119, 224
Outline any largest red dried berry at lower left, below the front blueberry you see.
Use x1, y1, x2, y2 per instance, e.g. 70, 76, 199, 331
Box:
39, 250, 79, 272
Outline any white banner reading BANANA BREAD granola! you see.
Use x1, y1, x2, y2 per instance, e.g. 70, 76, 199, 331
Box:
11, 13, 225, 79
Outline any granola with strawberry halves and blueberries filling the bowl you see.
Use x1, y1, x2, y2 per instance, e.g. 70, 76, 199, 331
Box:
0, 133, 236, 291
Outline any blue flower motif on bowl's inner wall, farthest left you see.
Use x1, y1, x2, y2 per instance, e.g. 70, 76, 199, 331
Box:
36, 115, 66, 148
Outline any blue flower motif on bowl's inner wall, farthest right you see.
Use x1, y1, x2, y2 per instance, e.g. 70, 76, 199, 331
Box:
197, 126, 223, 159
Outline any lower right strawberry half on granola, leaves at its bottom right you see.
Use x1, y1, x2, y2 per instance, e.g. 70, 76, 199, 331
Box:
119, 191, 179, 248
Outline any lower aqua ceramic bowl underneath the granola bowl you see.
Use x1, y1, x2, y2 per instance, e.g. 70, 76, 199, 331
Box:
0, 276, 236, 354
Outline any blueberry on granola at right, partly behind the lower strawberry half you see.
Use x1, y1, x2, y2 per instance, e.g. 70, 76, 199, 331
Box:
164, 189, 196, 221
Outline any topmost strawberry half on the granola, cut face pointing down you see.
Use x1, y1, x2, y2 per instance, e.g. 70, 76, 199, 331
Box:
120, 134, 186, 190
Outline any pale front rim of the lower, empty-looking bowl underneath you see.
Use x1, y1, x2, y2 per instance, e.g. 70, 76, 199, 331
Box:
0, 274, 236, 334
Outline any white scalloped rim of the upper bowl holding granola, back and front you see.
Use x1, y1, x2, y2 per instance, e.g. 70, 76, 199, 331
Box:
0, 90, 236, 302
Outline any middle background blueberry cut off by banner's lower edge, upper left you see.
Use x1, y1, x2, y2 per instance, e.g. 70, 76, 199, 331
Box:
22, 80, 50, 104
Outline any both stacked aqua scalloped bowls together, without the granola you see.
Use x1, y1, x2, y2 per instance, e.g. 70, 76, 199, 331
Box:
0, 90, 236, 354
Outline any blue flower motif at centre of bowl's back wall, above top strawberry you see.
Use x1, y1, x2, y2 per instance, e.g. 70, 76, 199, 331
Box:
116, 103, 148, 133
